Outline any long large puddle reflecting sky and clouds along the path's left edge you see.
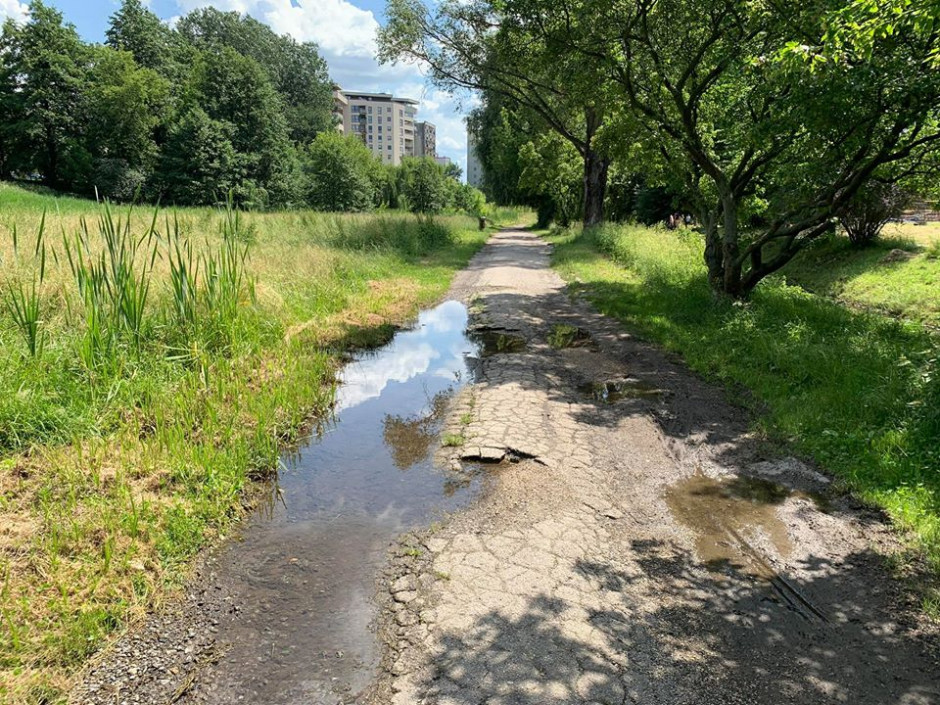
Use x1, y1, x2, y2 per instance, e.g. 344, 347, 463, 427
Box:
194, 302, 480, 705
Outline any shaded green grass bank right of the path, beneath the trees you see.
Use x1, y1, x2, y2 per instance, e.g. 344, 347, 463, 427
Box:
549, 226, 940, 572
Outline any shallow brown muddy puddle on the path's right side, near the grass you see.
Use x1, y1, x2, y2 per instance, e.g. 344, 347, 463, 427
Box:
666, 475, 793, 580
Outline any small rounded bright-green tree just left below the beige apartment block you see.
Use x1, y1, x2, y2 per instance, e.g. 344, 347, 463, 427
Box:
304, 132, 379, 211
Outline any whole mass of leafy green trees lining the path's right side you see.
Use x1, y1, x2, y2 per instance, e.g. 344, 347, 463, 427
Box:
379, 0, 940, 298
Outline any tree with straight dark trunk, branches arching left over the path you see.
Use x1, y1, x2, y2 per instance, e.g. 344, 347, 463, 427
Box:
379, 0, 610, 227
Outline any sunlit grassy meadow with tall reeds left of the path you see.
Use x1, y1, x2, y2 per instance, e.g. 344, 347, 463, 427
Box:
0, 184, 518, 703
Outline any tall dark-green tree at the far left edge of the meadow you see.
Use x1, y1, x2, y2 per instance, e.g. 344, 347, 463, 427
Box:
0, 0, 87, 188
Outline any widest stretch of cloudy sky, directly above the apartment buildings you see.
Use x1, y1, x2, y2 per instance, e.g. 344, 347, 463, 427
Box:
172, 0, 474, 173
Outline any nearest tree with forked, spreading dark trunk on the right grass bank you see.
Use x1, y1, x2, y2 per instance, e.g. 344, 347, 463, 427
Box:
505, 0, 940, 298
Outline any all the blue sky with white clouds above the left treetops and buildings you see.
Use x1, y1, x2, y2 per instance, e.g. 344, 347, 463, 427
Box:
0, 0, 470, 174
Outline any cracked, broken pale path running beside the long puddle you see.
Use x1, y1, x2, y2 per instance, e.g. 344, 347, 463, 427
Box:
375, 231, 940, 705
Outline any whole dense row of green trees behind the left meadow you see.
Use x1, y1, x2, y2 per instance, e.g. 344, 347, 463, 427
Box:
0, 0, 484, 210
